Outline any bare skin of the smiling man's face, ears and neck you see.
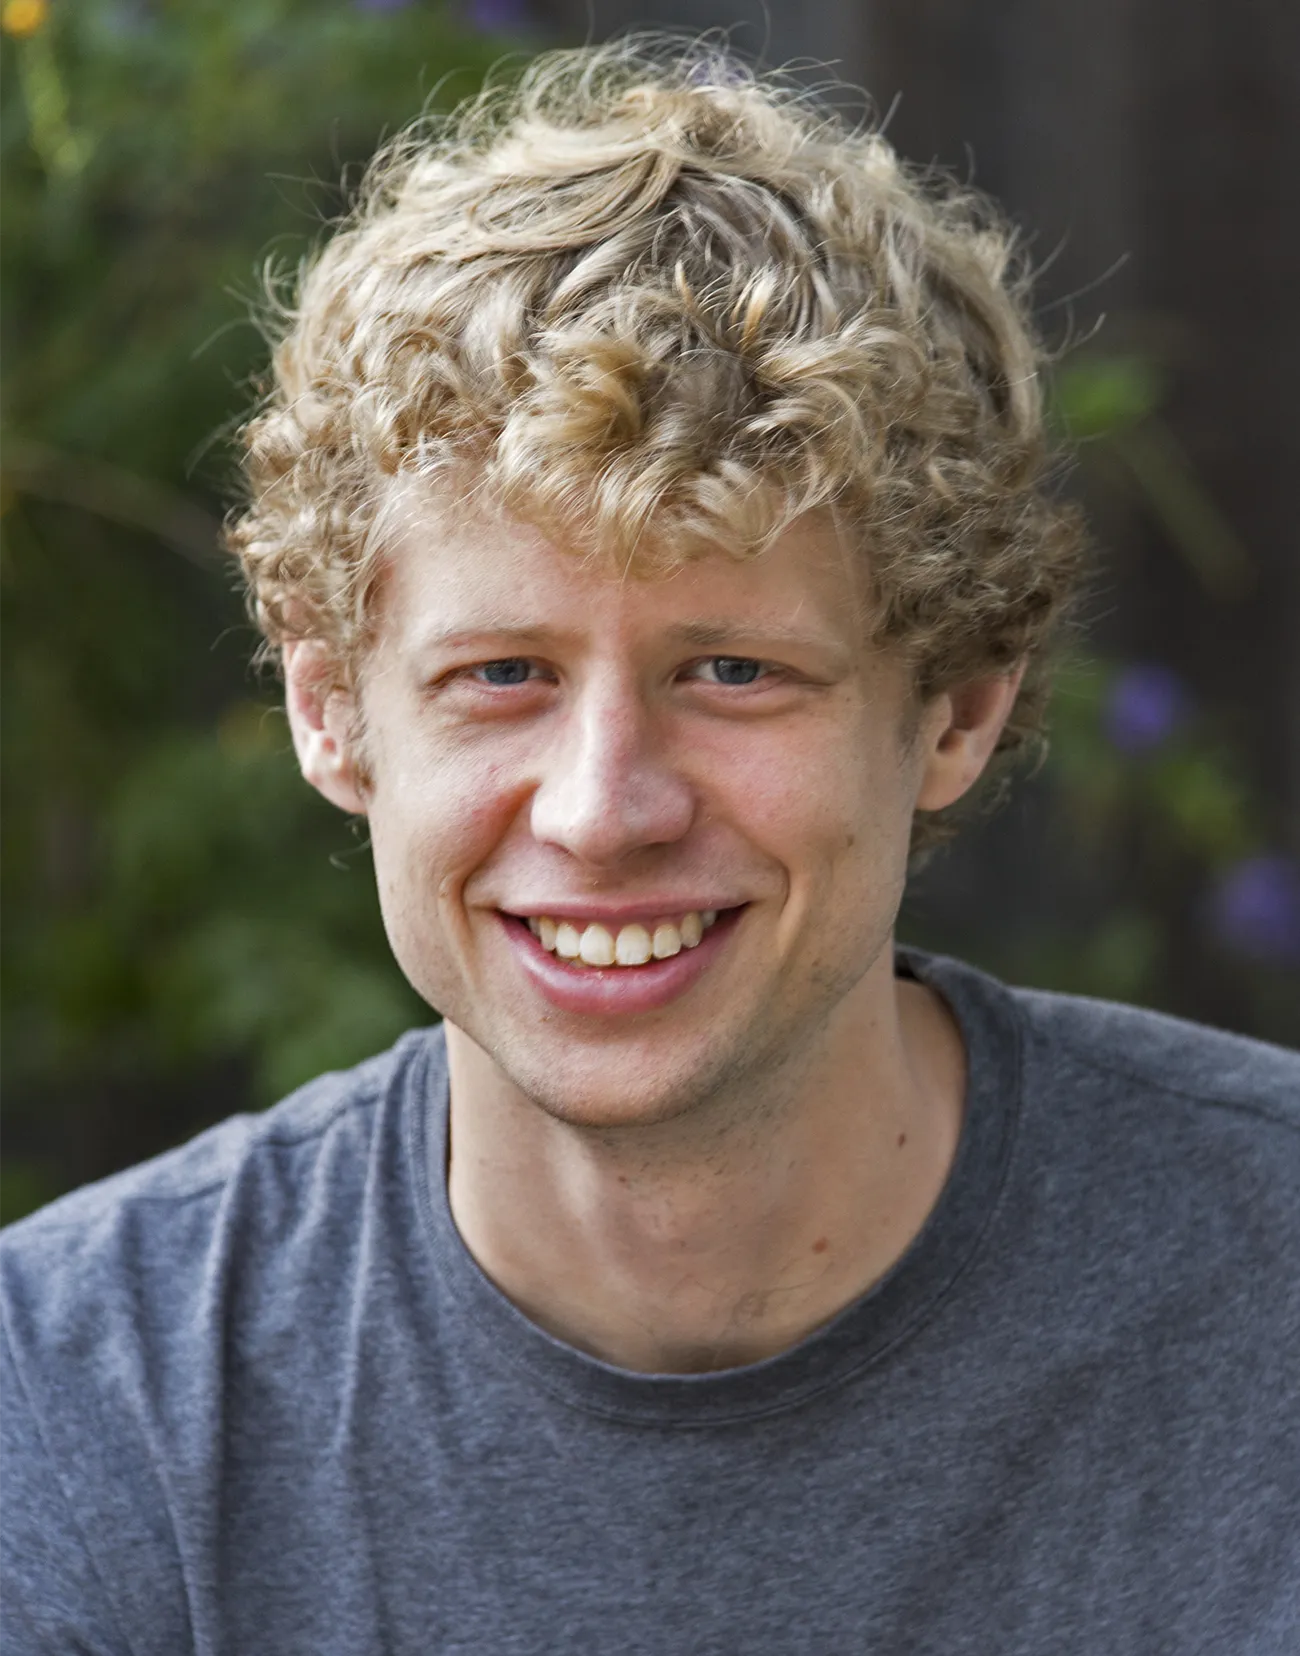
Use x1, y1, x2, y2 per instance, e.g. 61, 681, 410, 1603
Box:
296, 500, 993, 1373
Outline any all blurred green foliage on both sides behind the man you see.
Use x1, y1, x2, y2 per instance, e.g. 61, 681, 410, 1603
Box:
0, 0, 1300, 1220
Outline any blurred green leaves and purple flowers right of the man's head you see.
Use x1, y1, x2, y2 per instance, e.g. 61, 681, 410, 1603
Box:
904, 362, 1300, 1045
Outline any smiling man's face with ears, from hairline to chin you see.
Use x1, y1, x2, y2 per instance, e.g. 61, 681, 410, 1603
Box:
286, 497, 1009, 1126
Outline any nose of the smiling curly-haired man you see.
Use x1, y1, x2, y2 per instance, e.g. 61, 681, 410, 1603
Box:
532, 687, 696, 868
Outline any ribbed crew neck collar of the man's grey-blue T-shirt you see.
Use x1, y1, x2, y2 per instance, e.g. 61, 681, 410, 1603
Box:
404, 949, 1022, 1429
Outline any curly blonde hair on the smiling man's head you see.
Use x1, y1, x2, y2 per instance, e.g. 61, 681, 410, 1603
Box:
229, 36, 1080, 840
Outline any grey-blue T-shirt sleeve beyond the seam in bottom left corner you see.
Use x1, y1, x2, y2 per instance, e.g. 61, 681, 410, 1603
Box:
0, 1317, 131, 1656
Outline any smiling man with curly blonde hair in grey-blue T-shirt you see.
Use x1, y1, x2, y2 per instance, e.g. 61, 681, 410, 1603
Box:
0, 38, 1300, 1656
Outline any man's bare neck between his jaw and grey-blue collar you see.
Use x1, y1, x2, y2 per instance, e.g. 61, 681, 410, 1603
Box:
447, 952, 964, 1373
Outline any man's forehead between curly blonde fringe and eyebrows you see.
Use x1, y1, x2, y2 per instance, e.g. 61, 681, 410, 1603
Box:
376, 485, 869, 652
